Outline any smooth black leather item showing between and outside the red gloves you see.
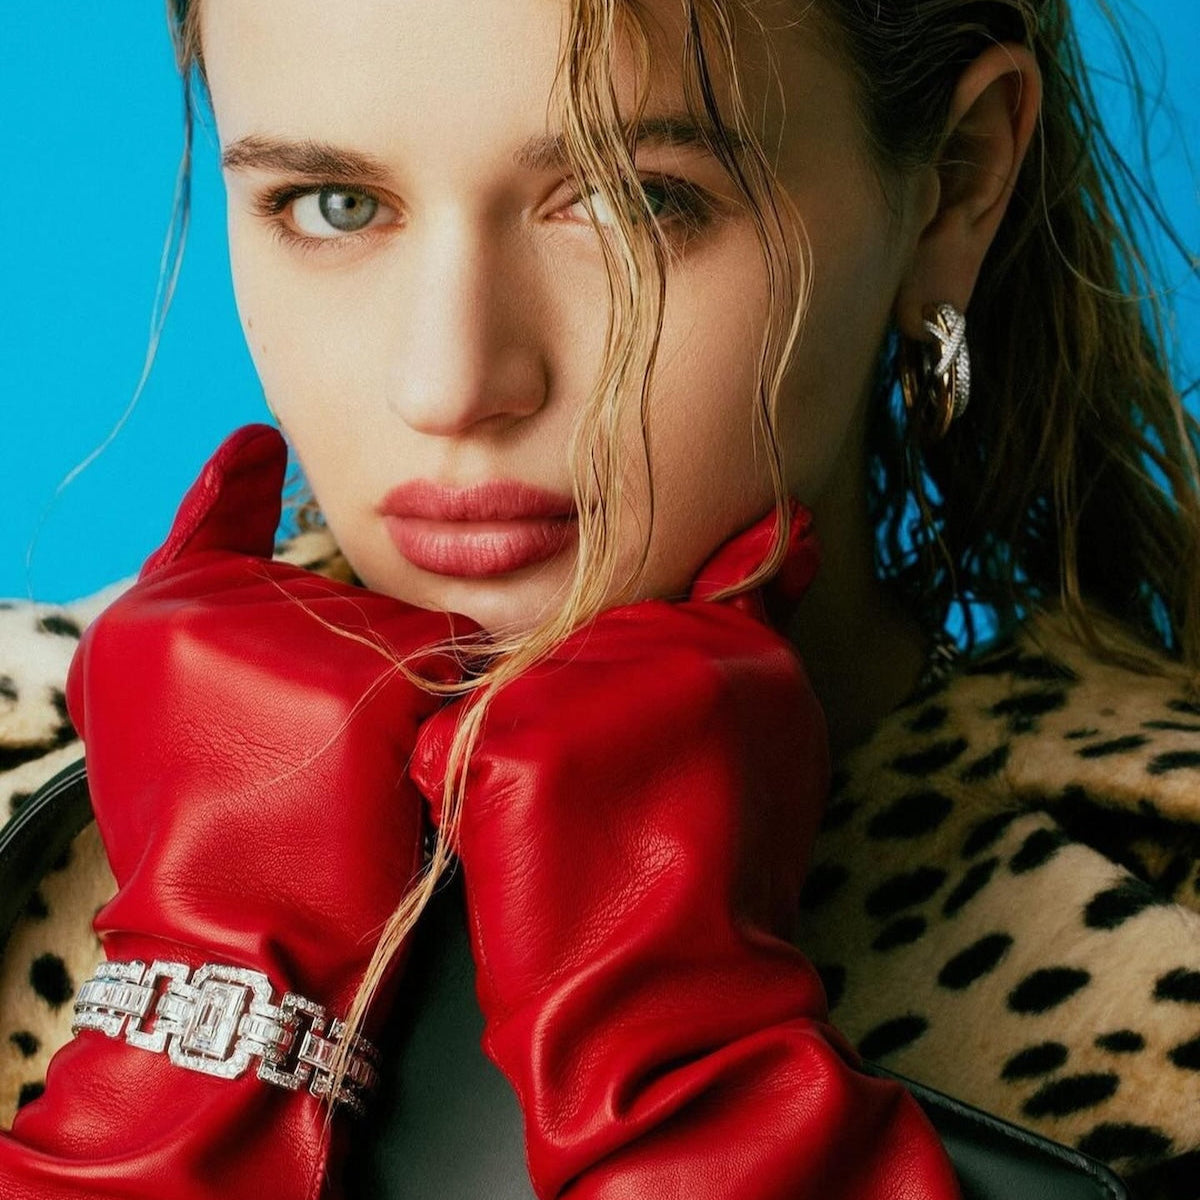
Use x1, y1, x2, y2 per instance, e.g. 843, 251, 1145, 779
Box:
0, 758, 1129, 1200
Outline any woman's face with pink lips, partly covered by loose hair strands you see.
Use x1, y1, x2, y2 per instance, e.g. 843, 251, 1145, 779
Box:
203, 0, 908, 632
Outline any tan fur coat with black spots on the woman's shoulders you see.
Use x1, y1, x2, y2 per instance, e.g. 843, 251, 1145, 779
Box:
0, 530, 1200, 1200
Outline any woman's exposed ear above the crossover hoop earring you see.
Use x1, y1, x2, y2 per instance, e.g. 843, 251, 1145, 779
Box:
895, 42, 1042, 341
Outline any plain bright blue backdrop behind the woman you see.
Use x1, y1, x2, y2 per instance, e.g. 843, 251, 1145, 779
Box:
7, 7, 1200, 602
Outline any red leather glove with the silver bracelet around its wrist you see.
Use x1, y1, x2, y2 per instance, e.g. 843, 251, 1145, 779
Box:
0, 425, 469, 1200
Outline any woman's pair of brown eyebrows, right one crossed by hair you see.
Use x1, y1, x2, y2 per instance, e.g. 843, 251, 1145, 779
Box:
221, 113, 745, 184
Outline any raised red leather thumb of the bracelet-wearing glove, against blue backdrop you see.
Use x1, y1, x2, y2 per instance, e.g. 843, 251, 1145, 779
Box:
138, 424, 288, 580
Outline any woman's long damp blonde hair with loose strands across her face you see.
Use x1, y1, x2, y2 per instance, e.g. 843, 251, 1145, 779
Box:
168, 0, 1200, 1171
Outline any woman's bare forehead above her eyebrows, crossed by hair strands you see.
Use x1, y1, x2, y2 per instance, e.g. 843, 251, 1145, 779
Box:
200, 0, 849, 178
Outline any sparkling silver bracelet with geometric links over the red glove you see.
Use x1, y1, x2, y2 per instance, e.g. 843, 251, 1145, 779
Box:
71, 960, 379, 1116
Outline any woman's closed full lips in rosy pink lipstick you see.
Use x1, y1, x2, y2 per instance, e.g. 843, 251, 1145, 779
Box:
379, 480, 576, 578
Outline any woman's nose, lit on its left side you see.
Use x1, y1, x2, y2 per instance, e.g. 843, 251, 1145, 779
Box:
388, 220, 547, 437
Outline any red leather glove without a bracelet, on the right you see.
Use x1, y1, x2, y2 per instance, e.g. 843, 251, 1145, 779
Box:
412, 505, 960, 1200
